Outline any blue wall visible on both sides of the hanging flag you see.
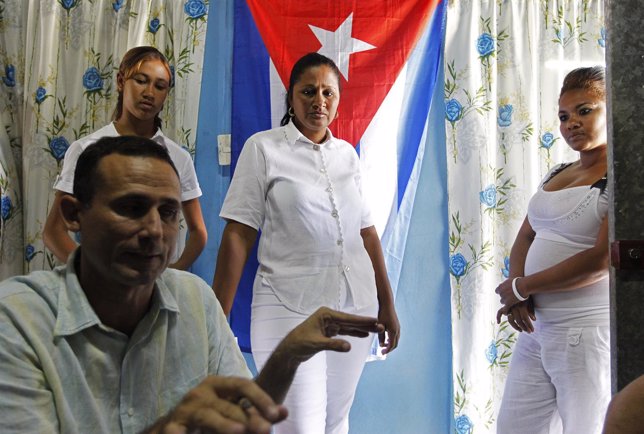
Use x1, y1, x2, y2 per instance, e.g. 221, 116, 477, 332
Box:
193, 0, 452, 434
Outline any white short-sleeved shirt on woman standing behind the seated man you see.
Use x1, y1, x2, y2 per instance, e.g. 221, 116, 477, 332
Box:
54, 122, 201, 202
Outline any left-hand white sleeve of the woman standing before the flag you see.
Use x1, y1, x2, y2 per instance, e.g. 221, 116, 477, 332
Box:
219, 138, 267, 230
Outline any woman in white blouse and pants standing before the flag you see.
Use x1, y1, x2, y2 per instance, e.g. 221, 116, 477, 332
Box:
213, 53, 400, 434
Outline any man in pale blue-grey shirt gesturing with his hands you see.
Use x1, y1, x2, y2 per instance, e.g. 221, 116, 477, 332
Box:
0, 136, 383, 433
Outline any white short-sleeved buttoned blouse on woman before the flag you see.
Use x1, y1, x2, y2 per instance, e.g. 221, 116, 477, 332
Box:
220, 123, 376, 314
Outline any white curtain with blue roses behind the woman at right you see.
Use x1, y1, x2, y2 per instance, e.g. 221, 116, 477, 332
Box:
445, 0, 606, 434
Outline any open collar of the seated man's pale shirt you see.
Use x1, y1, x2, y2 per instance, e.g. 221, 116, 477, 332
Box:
54, 247, 179, 336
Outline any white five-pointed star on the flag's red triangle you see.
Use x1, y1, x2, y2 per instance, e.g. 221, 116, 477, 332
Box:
309, 12, 376, 81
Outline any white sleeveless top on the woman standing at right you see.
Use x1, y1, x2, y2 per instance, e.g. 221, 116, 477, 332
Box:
525, 166, 609, 327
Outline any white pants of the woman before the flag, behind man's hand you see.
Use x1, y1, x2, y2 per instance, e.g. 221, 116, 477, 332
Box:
250, 278, 378, 434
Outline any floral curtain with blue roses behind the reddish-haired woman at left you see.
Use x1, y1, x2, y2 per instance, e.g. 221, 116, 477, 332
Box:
0, 0, 208, 278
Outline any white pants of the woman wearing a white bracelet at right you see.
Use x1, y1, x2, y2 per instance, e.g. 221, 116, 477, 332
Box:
497, 322, 611, 434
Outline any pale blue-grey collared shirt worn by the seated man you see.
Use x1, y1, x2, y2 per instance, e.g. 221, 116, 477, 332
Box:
0, 250, 250, 434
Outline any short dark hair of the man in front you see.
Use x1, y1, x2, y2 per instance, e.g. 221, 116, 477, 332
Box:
74, 136, 179, 205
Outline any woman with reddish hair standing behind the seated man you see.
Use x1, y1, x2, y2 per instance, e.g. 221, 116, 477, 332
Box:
43, 46, 208, 270
